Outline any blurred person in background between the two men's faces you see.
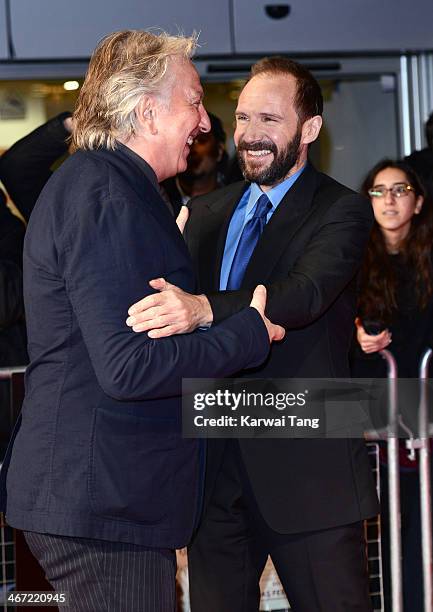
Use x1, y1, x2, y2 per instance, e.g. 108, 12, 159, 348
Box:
161, 113, 228, 216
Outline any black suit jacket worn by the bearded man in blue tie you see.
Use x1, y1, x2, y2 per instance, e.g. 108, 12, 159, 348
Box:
186, 165, 378, 533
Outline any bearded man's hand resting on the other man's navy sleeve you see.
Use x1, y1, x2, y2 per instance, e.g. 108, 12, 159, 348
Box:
126, 278, 213, 338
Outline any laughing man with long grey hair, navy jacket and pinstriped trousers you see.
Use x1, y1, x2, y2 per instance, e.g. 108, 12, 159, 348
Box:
2, 31, 284, 612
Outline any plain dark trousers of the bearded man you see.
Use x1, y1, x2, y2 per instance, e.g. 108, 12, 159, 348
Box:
188, 444, 372, 612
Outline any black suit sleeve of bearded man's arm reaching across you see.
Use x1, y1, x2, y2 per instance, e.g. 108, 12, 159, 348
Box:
207, 194, 373, 329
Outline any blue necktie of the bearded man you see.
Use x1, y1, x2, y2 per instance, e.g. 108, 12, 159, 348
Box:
227, 193, 272, 289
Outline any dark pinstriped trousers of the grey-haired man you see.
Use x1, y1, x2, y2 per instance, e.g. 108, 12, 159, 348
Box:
24, 531, 176, 612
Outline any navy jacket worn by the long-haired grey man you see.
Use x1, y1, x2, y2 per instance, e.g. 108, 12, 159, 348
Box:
1, 145, 269, 548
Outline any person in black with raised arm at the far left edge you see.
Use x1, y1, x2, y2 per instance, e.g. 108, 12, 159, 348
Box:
0, 112, 72, 461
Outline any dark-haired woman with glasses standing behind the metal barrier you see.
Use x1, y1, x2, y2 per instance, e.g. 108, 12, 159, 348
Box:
352, 160, 433, 612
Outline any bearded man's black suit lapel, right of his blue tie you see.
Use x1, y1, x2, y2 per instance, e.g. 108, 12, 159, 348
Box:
242, 164, 320, 288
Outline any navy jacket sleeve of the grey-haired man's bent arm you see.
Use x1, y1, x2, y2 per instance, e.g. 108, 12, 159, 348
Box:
61, 194, 269, 401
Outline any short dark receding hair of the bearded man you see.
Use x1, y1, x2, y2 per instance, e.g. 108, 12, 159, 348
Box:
251, 55, 323, 123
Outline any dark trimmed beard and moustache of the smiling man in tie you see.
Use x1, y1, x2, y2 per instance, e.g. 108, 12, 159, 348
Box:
237, 128, 302, 187
